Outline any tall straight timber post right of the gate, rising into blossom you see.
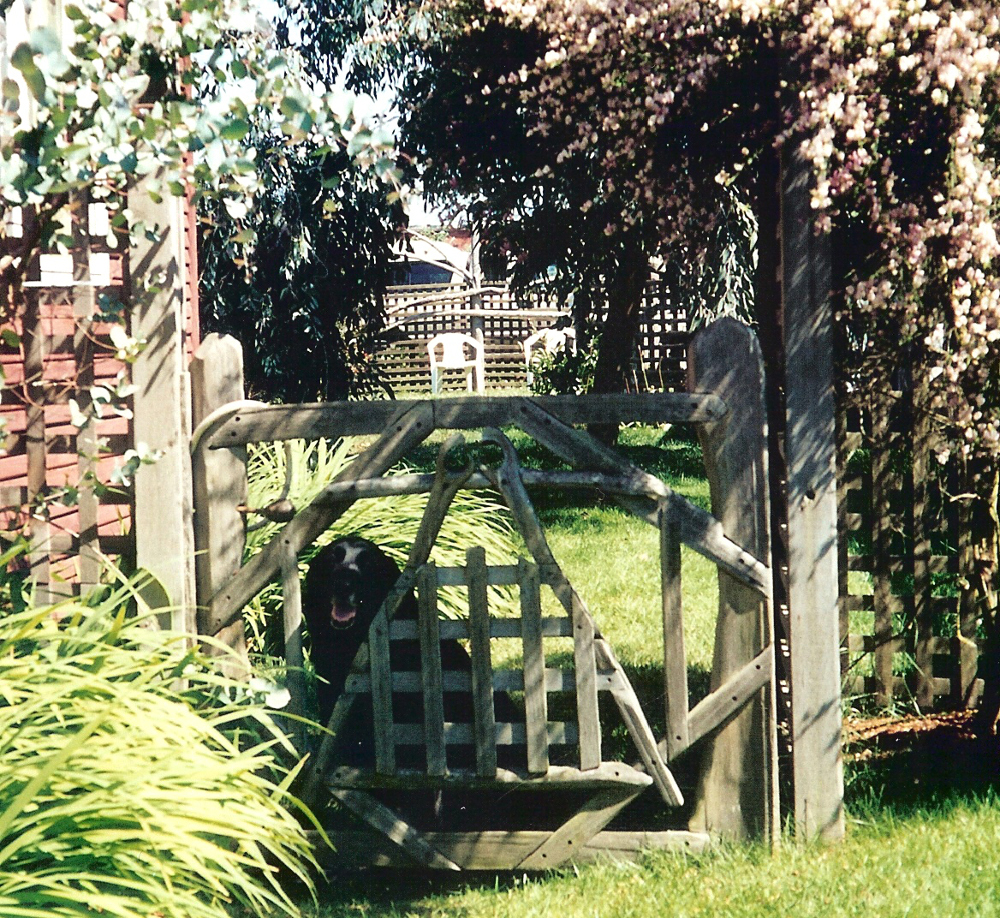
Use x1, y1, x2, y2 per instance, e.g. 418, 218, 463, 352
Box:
781, 145, 844, 841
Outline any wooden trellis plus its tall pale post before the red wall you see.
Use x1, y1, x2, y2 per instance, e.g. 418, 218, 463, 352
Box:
0, 179, 198, 627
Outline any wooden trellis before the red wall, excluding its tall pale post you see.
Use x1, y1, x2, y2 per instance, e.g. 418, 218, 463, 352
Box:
0, 201, 131, 602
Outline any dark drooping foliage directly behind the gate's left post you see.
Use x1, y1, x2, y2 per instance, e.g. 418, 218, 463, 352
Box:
199, 138, 399, 402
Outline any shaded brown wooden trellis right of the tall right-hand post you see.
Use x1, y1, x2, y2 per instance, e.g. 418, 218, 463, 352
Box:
838, 378, 982, 711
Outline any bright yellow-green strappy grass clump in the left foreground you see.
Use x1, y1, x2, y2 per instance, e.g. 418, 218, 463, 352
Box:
0, 590, 314, 918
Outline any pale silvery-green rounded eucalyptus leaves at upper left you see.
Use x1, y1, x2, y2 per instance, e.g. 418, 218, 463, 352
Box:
0, 0, 393, 320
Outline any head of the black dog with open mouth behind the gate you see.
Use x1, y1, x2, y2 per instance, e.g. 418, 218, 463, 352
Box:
306, 536, 399, 631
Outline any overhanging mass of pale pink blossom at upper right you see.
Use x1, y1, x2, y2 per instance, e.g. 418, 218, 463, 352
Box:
398, 0, 1000, 724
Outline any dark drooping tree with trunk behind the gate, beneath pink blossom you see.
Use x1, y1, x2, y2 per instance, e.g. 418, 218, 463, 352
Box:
400, 0, 755, 391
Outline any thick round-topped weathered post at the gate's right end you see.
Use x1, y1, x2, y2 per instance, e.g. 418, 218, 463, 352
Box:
688, 319, 778, 841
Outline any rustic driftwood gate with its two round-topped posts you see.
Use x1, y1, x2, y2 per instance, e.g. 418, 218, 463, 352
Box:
192, 320, 777, 869
